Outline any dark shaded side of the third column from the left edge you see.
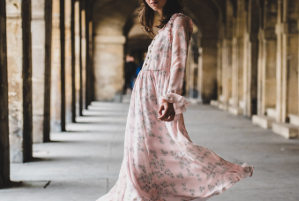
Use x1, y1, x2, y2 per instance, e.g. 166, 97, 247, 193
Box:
43, 0, 53, 142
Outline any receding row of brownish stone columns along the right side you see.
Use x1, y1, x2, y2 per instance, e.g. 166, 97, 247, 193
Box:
203, 0, 299, 138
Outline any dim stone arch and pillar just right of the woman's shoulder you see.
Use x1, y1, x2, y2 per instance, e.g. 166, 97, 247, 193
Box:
185, 1, 220, 102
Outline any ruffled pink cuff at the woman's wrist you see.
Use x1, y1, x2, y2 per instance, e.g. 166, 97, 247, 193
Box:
161, 93, 190, 115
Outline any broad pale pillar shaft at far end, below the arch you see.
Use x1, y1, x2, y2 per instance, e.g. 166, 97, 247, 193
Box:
94, 35, 125, 100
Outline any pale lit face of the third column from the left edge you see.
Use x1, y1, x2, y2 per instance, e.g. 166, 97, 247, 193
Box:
31, 0, 46, 143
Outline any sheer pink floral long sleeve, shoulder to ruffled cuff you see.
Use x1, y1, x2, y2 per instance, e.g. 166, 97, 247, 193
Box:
162, 15, 192, 114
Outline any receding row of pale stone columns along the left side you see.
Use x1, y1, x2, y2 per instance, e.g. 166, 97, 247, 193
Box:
0, 0, 93, 188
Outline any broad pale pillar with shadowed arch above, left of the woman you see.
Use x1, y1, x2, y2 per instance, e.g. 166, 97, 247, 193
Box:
93, 0, 137, 100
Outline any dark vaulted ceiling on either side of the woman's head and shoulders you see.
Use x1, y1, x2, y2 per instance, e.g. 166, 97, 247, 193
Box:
92, 0, 237, 37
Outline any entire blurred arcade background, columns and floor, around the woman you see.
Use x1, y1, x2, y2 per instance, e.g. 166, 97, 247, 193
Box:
0, 0, 299, 201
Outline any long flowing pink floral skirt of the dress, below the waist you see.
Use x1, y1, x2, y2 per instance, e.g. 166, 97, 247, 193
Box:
97, 70, 253, 201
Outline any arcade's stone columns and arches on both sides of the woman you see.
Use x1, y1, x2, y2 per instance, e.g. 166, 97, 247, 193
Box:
0, 0, 299, 187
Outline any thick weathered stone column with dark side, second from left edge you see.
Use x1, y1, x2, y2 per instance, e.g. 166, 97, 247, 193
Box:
6, 0, 32, 162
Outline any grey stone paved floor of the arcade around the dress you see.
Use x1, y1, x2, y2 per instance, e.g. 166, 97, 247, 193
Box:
0, 102, 299, 201
